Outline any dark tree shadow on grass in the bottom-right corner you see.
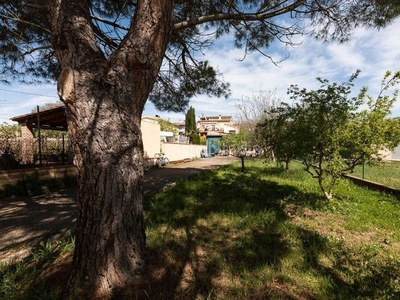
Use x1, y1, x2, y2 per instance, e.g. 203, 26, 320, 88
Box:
298, 228, 400, 299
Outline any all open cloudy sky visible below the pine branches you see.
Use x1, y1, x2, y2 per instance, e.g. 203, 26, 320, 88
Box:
0, 18, 400, 123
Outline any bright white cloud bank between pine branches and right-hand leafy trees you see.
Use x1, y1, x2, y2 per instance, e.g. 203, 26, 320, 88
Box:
180, 19, 400, 120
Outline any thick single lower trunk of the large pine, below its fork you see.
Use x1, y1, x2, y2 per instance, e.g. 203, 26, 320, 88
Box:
67, 74, 145, 298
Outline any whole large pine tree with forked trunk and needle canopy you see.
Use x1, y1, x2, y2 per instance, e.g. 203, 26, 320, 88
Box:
0, 0, 399, 298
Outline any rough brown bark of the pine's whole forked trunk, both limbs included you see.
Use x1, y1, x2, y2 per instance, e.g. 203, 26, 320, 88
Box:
48, 0, 173, 299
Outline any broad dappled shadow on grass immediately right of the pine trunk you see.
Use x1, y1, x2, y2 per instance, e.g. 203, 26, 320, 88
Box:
136, 168, 310, 299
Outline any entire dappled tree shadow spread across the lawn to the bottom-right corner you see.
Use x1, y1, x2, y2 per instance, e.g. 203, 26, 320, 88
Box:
133, 165, 399, 299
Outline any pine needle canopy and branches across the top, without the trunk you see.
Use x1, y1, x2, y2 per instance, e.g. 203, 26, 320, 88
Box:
0, 0, 400, 111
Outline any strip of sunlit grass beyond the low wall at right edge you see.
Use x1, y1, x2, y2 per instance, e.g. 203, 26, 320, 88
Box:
351, 161, 400, 189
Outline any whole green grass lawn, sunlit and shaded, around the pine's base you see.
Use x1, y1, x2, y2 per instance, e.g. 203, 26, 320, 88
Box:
0, 160, 400, 299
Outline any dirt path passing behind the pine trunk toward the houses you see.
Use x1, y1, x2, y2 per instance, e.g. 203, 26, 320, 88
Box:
0, 156, 237, 263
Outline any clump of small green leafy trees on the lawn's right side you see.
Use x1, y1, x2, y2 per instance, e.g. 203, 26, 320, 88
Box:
262, 71, 400, 199
